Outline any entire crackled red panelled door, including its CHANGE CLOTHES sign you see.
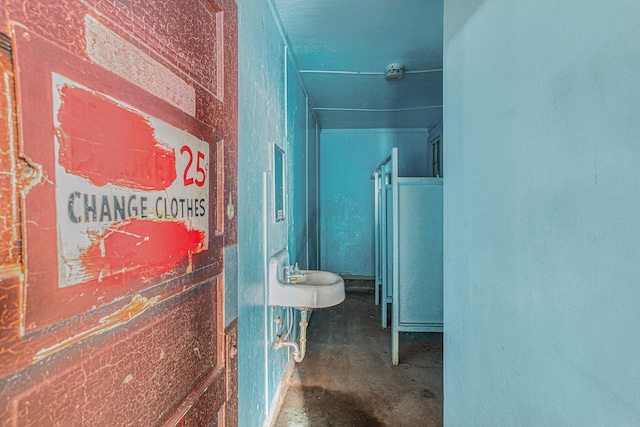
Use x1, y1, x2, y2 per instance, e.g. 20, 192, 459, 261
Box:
0, 0, 238, 426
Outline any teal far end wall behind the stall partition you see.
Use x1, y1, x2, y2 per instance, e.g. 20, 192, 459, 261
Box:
320, 129, 431, 276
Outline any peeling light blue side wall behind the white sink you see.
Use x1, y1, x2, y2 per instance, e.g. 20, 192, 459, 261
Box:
237, 0, 316, 427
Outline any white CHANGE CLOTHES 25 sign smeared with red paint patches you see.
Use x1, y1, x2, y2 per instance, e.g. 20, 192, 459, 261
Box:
52, 74, 209, 287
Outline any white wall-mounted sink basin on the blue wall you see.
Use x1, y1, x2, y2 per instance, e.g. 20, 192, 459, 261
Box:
269, 249, 344, 309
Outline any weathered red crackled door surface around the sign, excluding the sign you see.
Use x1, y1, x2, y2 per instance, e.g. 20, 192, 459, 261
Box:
0, 0, 237, 426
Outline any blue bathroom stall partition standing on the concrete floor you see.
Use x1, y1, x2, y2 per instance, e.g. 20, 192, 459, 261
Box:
372, 148, 443, 365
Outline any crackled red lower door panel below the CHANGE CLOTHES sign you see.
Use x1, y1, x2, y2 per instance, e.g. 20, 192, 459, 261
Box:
0, 282, 225, 426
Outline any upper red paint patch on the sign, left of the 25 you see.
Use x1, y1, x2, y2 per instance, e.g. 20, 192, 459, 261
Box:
54, 84, 176, 190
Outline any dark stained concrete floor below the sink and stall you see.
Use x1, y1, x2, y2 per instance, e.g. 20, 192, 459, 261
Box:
275, 281, 443, 427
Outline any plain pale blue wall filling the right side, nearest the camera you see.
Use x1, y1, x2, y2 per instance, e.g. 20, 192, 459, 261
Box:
444, 0, 640, 427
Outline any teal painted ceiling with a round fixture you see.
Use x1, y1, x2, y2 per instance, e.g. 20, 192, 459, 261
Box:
273, 0, 443, 129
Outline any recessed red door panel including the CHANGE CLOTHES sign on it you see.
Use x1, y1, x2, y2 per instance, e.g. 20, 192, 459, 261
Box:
15, 28, 217, 334
